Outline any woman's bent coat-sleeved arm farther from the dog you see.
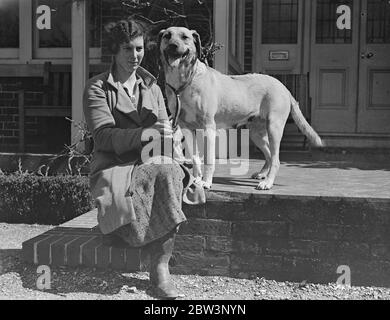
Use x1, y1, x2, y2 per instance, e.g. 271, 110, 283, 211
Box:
83, 80, 143, 155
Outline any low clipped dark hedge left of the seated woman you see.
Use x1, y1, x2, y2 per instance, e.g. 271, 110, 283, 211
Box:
0, 173, 94, 225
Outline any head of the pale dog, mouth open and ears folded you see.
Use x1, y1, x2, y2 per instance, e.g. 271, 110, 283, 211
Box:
158, 27, 201, 67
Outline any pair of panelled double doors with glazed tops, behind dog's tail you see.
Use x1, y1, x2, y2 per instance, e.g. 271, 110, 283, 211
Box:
310, 0, 390, 134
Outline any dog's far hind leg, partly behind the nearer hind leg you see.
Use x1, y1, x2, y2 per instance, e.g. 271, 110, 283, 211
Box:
248, 118, 271, 180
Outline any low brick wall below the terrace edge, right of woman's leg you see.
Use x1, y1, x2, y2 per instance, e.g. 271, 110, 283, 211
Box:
172, 192, 390, 286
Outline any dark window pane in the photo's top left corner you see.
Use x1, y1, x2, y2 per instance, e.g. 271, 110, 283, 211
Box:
0, 0, 19, 48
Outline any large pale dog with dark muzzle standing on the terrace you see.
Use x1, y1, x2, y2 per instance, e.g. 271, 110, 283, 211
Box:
158, 27, 324, 190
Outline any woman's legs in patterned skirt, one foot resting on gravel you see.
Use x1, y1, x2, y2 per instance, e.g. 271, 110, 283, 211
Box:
114, 164, 186, 298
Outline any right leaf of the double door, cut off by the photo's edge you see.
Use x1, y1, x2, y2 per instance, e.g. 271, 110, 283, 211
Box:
357, 0, 390, 133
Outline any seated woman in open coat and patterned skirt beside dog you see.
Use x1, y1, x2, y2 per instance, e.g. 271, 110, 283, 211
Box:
83, 18, 204, 298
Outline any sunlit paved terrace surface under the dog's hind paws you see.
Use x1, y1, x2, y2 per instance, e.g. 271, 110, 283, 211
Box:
213, 159, 390, 199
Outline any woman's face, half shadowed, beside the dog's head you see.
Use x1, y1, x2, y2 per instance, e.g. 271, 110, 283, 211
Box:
115, 36, 145, 73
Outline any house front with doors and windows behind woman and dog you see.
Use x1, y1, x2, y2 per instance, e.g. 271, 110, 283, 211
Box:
0, 0, 390, 153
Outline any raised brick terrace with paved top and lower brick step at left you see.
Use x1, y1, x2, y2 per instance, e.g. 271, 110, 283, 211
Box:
23, 161, 390, 286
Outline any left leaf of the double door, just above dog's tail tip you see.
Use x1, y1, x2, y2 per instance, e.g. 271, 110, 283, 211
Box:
310, 0, 359, 133
